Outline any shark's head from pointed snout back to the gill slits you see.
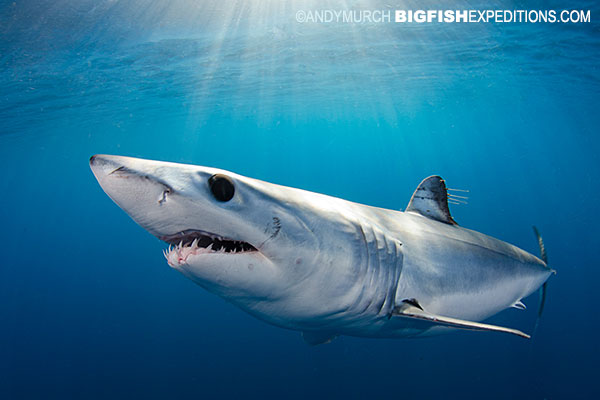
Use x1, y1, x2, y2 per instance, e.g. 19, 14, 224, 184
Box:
90, 155, 376, 323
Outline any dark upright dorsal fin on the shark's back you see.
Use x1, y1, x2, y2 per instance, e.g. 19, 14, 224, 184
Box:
406, 175, 458, 225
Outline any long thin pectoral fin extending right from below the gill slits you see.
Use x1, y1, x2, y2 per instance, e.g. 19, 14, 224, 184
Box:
392, 299, 530, 339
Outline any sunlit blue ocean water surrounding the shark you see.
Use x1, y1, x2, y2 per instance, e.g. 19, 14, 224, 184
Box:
0, 0, 600, 399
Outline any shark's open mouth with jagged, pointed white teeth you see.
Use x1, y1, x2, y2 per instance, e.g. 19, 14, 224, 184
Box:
160, 229, 258, 267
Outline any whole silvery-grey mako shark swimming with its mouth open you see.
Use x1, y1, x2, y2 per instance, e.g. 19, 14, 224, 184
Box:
90, 155, 554, 344
